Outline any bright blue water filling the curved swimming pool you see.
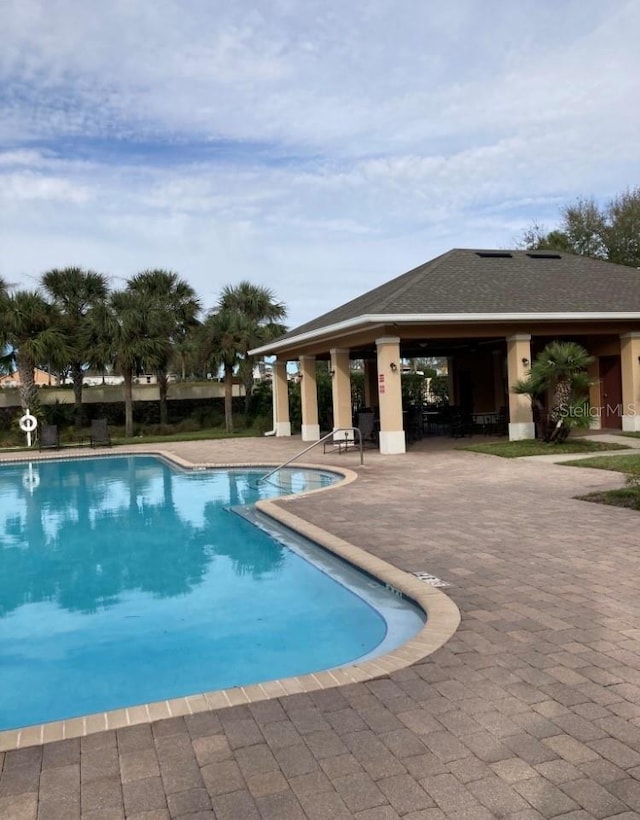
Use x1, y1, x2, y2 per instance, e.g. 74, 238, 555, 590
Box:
0, 457, 422, 729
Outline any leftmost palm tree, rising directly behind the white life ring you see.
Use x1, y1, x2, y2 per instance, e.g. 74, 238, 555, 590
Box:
0, 290, 67, 410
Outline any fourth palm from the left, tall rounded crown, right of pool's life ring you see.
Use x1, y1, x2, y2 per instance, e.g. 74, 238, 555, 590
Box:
127, 269, 200, 424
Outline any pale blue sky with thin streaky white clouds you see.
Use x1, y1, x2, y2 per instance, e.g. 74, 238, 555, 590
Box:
0, 0, 640, 327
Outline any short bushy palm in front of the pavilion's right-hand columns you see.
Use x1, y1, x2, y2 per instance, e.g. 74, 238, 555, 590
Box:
513, 341, 594, 442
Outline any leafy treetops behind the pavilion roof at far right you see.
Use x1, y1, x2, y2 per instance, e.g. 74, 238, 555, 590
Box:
518, 186, 640, 268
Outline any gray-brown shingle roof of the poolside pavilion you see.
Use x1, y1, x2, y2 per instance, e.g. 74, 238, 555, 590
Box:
277, 249, 640, 342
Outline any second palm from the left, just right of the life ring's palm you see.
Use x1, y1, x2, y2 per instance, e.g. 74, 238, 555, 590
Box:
42, 268, 109, 429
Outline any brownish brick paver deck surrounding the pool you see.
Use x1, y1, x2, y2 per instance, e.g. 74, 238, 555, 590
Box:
0, 432, 640, 820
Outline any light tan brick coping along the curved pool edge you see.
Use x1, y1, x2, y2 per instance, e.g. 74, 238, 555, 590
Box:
0, 446, 461, 752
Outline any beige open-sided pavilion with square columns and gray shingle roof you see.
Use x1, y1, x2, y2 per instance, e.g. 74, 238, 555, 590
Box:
252, 250, 640, 454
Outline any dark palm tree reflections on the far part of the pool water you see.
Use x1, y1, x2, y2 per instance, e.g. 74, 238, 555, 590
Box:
0, 457, 283, 617
